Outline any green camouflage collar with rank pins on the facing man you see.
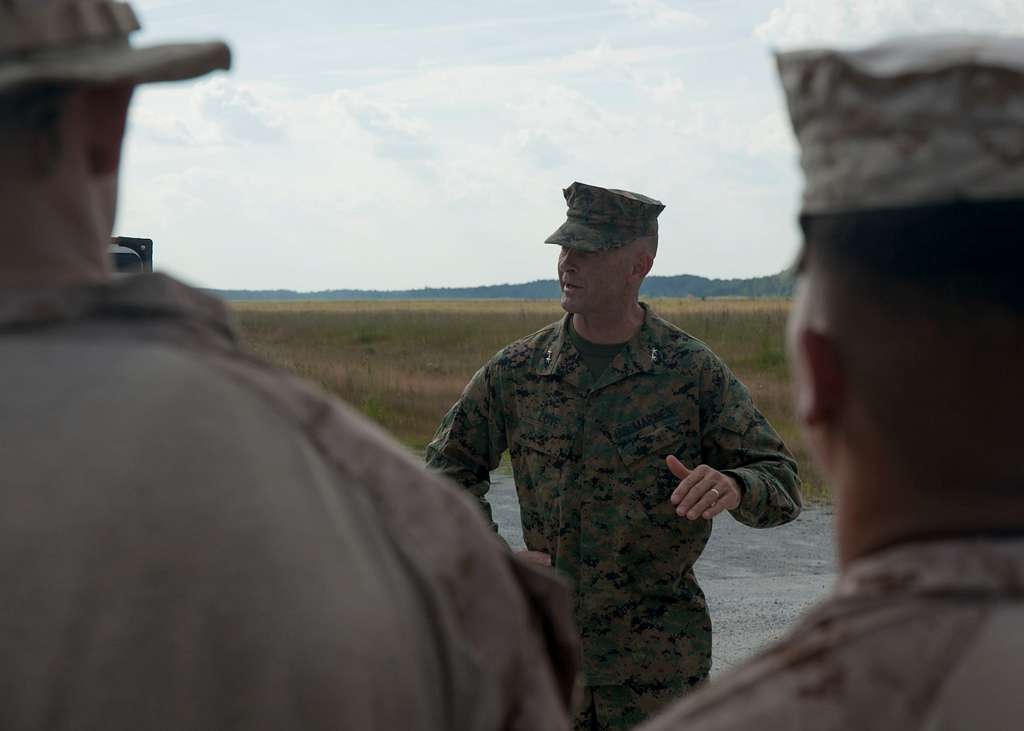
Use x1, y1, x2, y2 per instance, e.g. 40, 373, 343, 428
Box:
537, 302, 665, 388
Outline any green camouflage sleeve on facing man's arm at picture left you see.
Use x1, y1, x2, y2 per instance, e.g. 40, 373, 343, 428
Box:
426, 360, 508, 530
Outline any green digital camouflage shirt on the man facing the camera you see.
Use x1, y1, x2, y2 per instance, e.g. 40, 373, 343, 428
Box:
427, 306, 801, 687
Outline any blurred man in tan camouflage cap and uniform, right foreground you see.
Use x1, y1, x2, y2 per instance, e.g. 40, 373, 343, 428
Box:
644, 36, 1024, 731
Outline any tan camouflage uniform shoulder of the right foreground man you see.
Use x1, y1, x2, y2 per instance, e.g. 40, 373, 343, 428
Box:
638, 536, 1024, 731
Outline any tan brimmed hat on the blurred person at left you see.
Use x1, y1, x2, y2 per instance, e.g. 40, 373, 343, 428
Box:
0, 0, 231, 93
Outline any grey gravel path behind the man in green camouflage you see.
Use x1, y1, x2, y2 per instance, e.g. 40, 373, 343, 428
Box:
488, 474, 836, 675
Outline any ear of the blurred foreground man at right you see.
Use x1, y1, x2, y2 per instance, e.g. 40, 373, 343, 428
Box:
796, 330, 848, 428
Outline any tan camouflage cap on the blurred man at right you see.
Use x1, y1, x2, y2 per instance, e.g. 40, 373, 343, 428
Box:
777, 35, 1024, 215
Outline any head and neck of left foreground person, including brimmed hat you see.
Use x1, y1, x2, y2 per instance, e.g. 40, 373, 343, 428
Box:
0, 0, 230, 288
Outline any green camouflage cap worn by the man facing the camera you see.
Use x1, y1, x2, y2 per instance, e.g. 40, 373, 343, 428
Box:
544, 182, 665, 251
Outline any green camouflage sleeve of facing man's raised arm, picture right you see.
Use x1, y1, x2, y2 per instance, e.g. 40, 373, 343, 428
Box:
700, 356, 803, 528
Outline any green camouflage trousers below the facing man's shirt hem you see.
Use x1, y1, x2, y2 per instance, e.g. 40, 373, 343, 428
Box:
574, 683, 704, 731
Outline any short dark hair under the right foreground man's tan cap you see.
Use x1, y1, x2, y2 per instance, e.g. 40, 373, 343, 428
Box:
800, 200, 1024, 315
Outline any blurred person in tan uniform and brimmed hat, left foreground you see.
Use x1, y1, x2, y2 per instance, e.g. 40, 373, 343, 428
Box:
0, 0, 574, 731
